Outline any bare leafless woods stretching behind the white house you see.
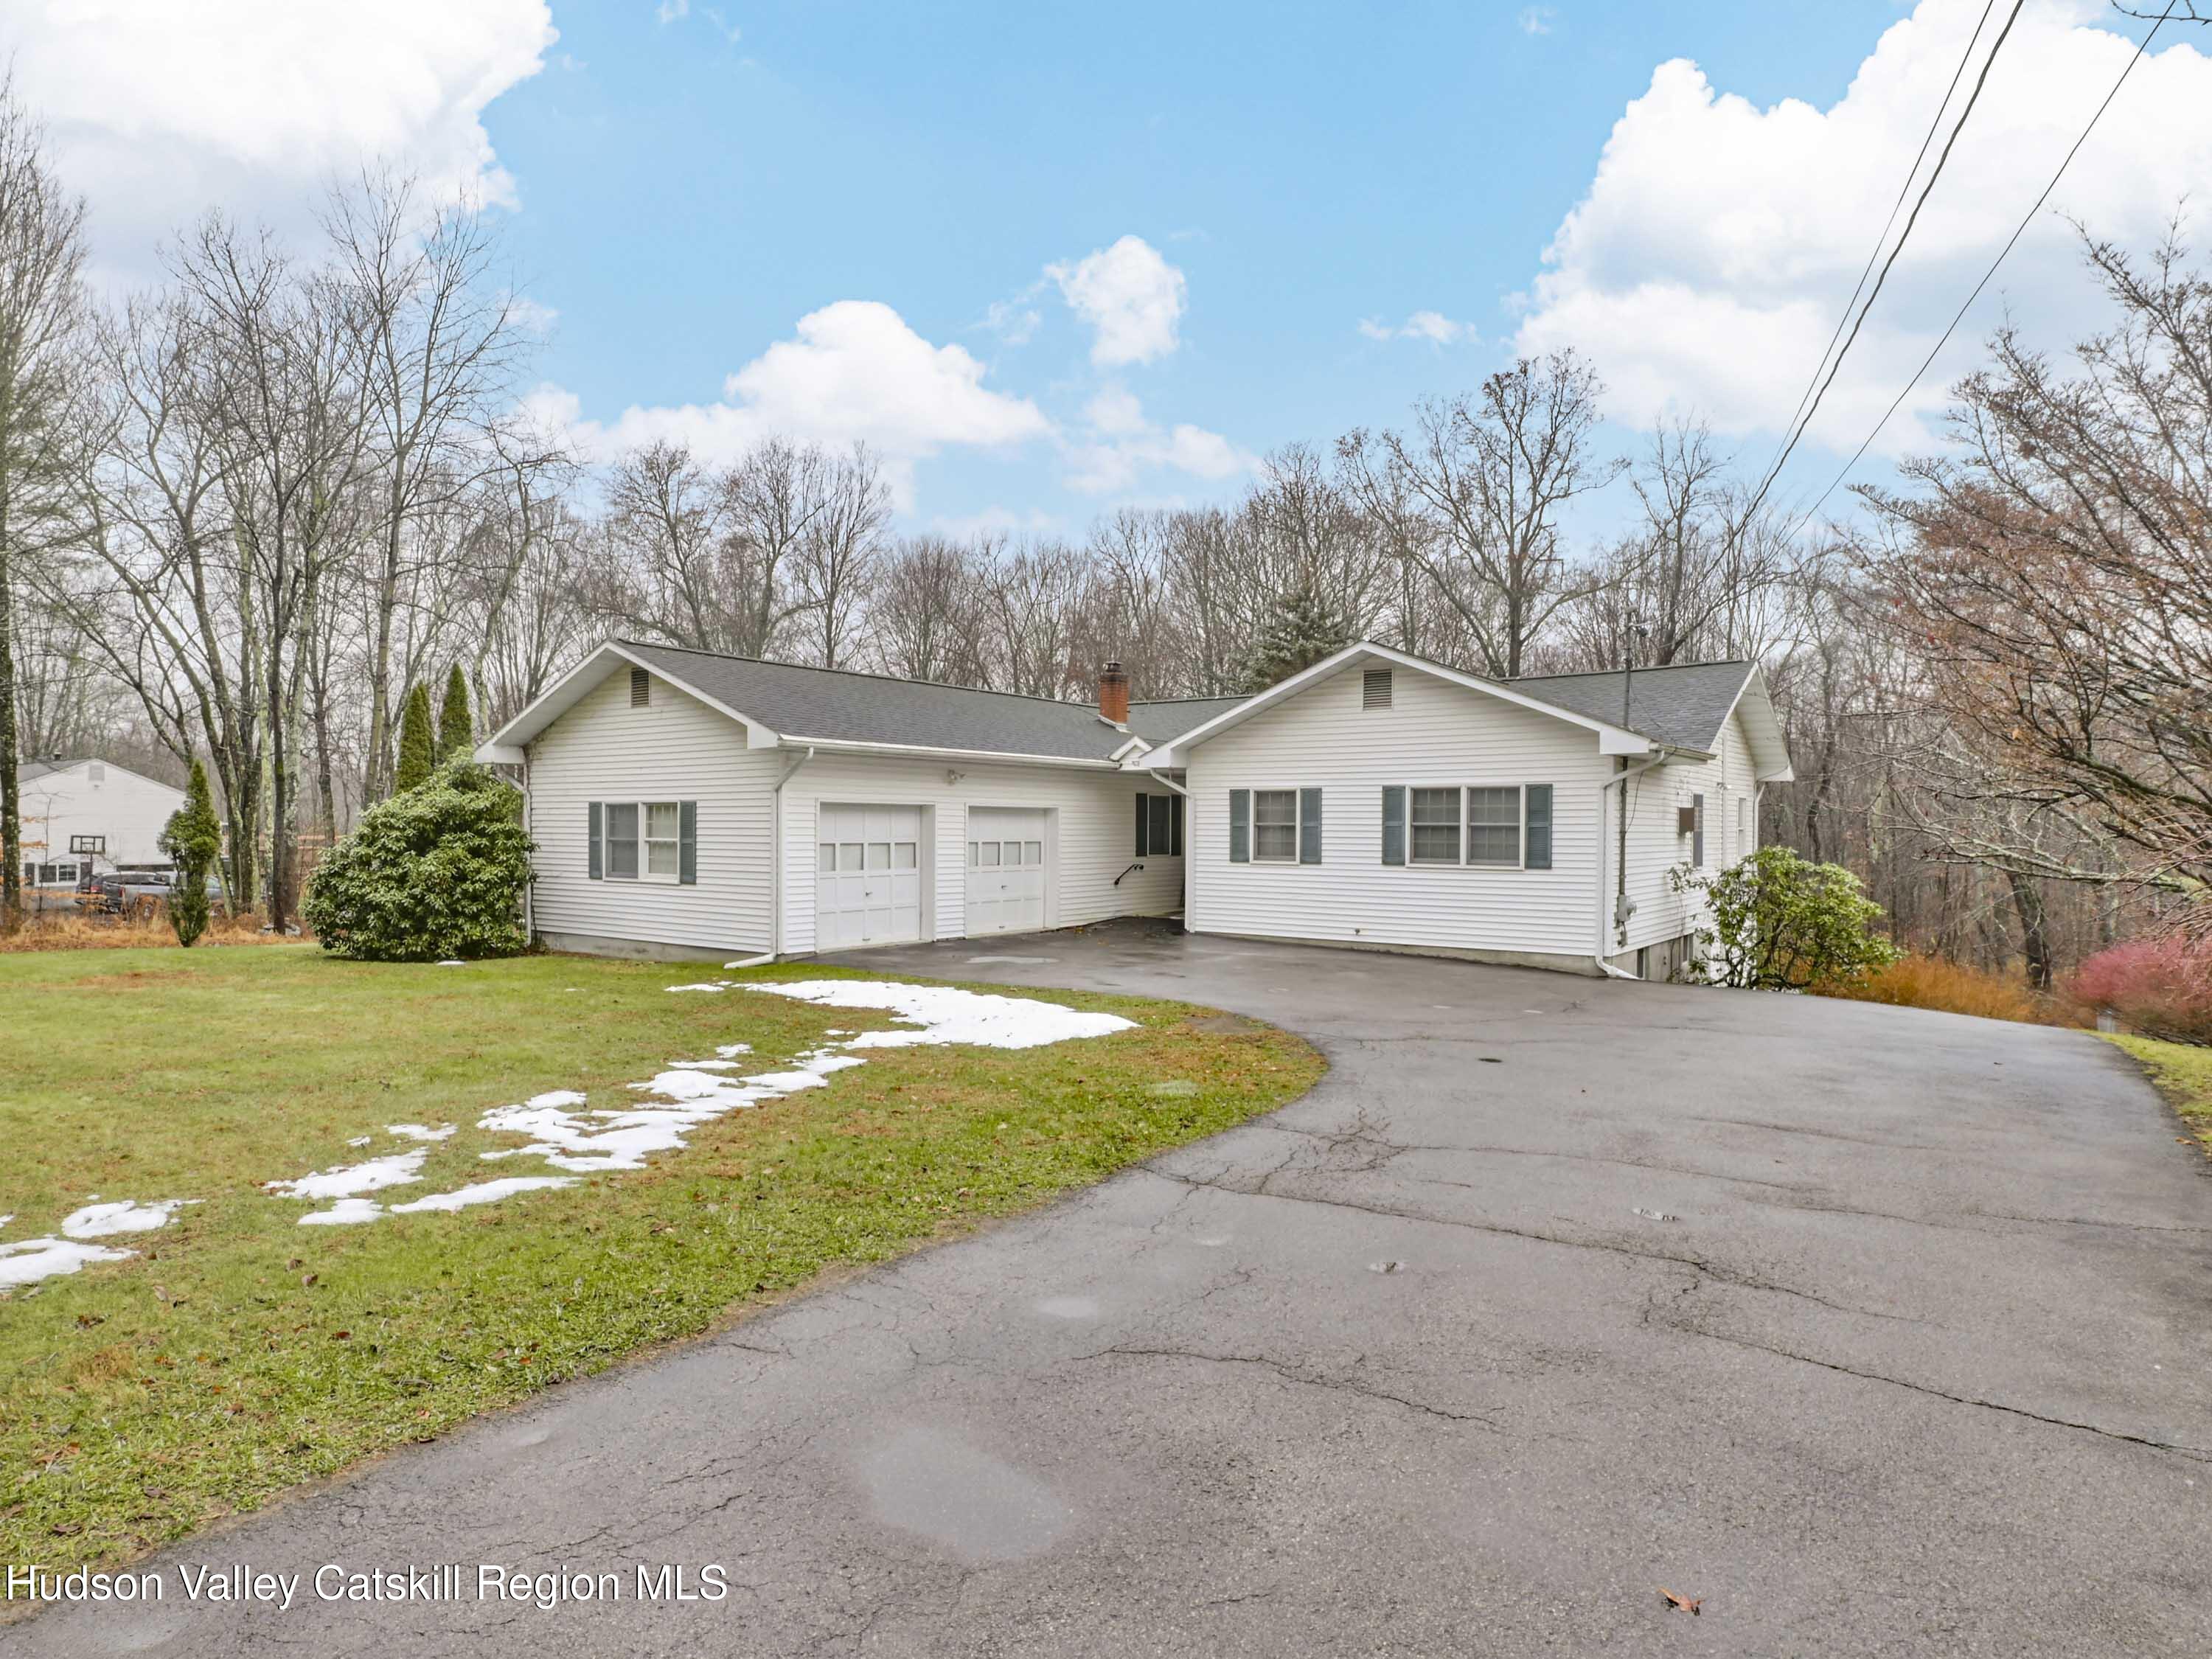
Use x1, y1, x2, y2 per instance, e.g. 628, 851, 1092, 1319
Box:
0, 88, 2212, 984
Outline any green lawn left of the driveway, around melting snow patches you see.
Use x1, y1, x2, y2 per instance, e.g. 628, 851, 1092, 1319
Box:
0, 947, 1323, 1566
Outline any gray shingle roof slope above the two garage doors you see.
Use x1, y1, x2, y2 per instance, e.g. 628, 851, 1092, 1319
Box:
619, 639, 1243, 761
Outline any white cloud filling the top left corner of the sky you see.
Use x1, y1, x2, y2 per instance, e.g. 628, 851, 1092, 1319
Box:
0, 0, 557, 272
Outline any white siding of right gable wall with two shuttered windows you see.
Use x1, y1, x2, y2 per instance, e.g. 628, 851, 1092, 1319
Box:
1186, 668, 1613, 962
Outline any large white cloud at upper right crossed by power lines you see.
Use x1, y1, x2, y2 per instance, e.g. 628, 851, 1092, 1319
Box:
1517, 0, 2212, 453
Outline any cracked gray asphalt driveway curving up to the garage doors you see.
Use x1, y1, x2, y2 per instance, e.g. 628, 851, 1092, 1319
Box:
17, 925, 2212, 1659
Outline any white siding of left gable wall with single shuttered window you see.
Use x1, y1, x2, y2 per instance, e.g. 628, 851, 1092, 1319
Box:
529, 672, 783, 956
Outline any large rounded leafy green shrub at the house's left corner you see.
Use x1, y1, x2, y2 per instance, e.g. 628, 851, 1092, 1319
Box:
301, 761, 531, 962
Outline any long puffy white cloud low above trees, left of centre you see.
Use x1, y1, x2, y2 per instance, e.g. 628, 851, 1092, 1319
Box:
533, 299, 1053, 502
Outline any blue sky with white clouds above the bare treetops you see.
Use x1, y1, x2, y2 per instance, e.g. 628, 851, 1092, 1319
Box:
17, 0, 2212, 533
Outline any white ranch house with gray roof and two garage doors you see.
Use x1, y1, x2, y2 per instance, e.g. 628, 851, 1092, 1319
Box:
478, 641, 1790, 973
